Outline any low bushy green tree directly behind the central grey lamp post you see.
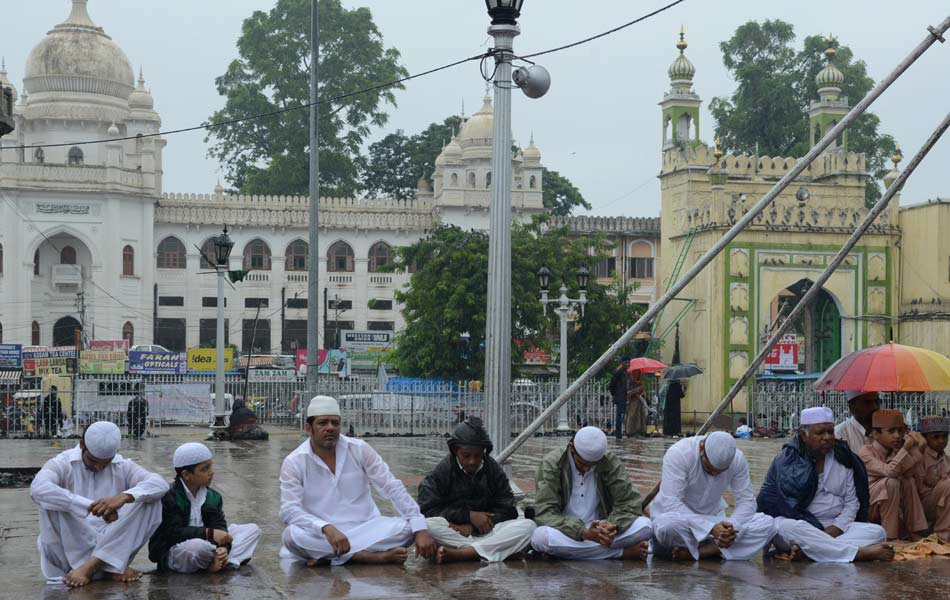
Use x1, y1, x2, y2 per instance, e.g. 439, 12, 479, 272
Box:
394, 219, 641, 379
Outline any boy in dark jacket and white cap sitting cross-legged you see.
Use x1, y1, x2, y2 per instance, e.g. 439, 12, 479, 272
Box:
148, 442, 261, 573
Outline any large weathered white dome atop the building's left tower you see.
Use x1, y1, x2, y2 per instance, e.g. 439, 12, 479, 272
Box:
23, 0, 134, 102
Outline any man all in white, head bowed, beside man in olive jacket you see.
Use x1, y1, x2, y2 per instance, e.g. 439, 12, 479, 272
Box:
650, 431, 773, 560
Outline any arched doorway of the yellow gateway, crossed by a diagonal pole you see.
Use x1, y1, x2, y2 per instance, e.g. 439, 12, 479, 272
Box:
761, 279, 841, 373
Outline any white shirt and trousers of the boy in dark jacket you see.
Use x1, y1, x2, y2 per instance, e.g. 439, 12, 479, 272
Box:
168, 485, 261, 573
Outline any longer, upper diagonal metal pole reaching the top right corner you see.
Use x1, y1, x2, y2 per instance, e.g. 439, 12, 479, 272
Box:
495, 16, 950, 462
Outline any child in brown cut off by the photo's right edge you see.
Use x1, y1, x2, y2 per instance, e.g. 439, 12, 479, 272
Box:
917, 417, 950, 544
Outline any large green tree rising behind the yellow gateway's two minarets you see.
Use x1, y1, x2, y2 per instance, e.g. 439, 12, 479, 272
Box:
709, 20, 894, 202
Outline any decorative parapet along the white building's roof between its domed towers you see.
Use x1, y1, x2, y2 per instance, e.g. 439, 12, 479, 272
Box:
155, 194, 435, 230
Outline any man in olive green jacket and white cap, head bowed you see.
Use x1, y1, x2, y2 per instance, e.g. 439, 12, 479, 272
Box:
531, 427, 653, 560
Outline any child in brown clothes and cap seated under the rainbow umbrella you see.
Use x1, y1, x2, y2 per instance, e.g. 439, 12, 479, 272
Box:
858, 409, 927, 540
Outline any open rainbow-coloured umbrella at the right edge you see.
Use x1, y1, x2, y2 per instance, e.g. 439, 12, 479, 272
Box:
815, 342, 950, 392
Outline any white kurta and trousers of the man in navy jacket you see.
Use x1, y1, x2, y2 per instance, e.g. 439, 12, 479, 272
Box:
773, 453, 885, 562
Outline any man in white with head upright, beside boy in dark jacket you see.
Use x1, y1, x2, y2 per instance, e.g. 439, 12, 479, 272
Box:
280, 396, 436, 566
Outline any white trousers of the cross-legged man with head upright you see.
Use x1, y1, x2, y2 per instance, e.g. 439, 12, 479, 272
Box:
280, 517, 415, 566
